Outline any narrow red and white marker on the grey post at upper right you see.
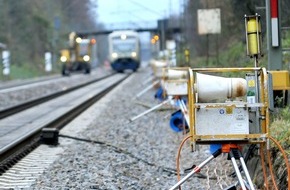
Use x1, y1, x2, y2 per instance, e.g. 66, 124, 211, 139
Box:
270, 0, 279, 47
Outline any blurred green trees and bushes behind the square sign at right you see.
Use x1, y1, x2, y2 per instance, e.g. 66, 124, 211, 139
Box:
180, 0, 290, 67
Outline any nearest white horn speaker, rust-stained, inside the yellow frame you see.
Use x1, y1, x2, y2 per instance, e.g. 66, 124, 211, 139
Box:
195, 73, 247, 103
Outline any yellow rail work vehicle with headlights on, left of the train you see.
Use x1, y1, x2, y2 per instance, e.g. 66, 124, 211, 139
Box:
60, 32, 96, 76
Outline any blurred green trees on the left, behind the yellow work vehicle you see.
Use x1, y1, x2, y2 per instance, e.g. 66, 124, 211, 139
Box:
0, 0, 102, 80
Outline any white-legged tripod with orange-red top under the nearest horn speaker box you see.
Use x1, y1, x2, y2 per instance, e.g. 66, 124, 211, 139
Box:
170, 144, 255, 190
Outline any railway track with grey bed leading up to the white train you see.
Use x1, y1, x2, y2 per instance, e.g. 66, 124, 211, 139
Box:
0, 74, 129, 177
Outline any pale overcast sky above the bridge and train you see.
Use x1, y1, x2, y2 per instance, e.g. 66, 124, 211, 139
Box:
97, 0, 183, 26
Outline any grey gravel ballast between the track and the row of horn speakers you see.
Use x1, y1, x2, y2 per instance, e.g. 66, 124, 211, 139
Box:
26, 68, 237, 190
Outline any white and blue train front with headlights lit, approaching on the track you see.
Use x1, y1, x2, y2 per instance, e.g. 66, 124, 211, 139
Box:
108, 30, 140, 72
